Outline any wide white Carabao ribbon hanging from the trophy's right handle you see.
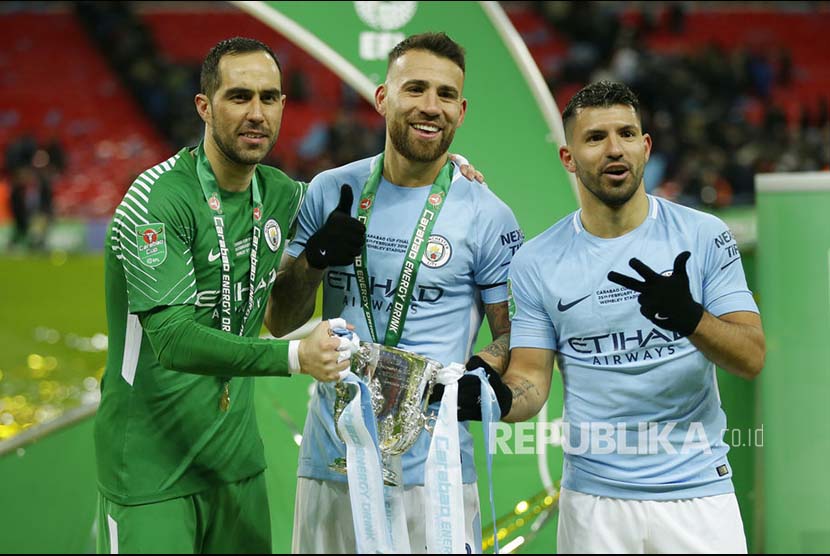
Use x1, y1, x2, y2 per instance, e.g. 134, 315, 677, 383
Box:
424, 363, 466, 554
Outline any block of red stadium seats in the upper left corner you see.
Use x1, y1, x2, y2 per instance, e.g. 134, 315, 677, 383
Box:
0, 11, 170, 217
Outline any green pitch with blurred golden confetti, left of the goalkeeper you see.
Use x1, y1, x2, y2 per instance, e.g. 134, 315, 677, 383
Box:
0, 253, 106, 441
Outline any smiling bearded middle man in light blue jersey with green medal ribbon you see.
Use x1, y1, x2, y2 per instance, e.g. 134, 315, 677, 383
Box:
270, 33, 523, 553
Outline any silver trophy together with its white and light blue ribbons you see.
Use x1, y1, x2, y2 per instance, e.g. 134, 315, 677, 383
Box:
331, 328, 500, 554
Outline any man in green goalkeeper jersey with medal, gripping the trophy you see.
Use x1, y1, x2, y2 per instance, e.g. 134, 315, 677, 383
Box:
95, 38, 364, 553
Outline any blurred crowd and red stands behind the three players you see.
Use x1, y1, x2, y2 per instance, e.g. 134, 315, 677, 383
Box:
0, 1, 830, 249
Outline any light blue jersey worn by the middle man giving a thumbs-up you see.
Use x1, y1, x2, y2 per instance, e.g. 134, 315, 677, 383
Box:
287, 157, 523, 485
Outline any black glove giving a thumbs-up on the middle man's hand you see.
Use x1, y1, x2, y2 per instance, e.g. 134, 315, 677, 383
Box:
305, 183, 366, 270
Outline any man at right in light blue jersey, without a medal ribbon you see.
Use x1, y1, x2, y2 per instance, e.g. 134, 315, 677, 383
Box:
504, 82, 765, 553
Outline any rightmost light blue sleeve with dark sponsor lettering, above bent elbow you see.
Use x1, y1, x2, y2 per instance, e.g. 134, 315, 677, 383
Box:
699, 216, 759, 317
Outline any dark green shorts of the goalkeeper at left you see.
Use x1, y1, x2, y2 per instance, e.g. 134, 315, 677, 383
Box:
98, 473, 271, 554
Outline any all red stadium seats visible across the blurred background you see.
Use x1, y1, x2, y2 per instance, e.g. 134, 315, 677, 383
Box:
0, 2, 830, 217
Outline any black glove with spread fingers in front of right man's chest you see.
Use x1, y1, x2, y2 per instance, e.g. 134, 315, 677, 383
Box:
608, 251, 703, 336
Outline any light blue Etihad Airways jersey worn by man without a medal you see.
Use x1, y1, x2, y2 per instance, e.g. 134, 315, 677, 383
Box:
510, 196, 758, 500
